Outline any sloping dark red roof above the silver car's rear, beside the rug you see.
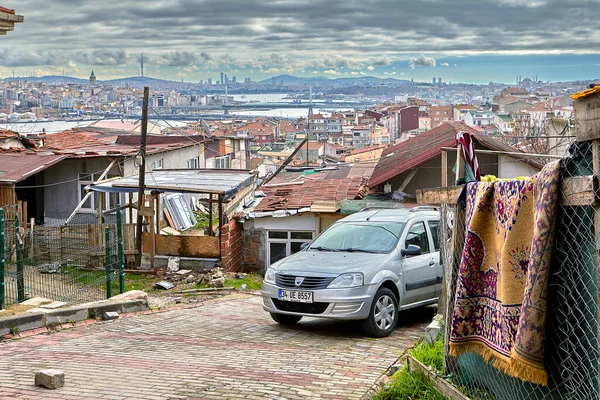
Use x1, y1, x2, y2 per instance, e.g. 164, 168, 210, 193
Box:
369, 121, 476, 187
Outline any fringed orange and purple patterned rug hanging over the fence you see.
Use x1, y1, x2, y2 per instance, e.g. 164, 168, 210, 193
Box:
450, 162, 560, 385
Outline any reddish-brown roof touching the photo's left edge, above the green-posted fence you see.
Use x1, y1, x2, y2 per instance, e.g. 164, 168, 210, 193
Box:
0, 153, 67, 183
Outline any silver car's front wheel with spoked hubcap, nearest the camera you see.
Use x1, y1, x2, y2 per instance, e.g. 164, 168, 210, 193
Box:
360, 287, 398, 337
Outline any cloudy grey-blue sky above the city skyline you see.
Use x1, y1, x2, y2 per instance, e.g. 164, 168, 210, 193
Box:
0, 0, 600, 82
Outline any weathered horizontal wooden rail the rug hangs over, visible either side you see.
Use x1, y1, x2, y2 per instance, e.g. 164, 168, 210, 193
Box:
417, 175, 600, 206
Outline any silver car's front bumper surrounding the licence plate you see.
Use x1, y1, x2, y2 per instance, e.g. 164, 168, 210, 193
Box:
261, 282, 377, 320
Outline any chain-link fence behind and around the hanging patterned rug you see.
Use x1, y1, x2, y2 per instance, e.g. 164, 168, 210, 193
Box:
441, 142, 600, 400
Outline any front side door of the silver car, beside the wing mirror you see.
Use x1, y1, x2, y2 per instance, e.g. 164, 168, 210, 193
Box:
402, 219, 439, 305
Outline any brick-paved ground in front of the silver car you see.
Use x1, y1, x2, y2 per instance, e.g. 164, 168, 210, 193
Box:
0, 296, 433, 400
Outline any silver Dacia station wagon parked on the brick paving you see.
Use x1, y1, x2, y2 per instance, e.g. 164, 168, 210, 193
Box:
262, 207, 442, 337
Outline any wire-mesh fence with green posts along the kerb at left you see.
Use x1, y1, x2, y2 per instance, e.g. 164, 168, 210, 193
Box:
0, 205, 133, 309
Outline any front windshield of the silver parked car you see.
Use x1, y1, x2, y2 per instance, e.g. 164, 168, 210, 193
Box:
309, 222, 404, 253
